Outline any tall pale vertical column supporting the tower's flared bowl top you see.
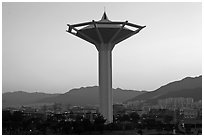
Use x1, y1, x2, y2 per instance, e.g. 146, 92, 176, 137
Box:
98, 44, 113, 123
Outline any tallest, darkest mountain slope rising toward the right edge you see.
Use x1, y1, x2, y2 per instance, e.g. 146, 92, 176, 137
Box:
125, 76, 202, 102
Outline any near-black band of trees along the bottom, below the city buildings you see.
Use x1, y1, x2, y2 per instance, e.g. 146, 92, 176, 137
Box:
2, 111, 202, 135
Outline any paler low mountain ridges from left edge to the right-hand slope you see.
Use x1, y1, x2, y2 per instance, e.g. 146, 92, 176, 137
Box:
2, 86, 145, 106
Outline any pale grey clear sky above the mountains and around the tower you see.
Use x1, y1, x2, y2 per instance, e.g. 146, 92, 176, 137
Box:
2, 2, 202, 93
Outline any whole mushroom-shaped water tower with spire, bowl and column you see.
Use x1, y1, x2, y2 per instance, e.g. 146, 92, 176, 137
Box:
67, 12, 145, 123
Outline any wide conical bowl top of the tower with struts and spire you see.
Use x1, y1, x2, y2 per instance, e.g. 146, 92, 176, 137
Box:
67, 12, 145, 48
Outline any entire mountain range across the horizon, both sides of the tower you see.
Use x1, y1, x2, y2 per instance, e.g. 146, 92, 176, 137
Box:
2, 76, 202, 106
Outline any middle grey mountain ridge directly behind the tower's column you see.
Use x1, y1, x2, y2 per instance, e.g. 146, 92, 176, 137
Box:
35, 86, 145, 105
